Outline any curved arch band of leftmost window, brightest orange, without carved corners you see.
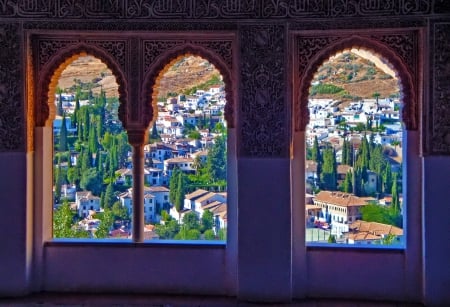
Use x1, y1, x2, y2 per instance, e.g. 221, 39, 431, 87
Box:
35, 43, 128, 129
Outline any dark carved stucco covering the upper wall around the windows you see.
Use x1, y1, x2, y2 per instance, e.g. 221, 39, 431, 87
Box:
0, 0, 450, 157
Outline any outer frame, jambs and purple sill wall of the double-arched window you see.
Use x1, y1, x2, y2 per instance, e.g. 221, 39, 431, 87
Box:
31, 31, 237, 295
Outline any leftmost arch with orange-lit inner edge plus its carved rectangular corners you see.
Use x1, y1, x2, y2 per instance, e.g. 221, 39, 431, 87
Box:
33, 38, 128, 127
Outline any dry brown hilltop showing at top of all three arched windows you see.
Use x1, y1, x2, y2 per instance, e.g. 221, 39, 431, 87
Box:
58, 49, 399, 101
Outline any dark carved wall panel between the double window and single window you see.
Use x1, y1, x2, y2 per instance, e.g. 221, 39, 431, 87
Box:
238, 25, 290, 158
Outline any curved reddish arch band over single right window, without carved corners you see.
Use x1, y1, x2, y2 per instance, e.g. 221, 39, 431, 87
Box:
294, 36, 418, 131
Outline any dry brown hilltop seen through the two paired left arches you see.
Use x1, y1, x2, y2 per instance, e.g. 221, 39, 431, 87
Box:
58, 56, 221, 97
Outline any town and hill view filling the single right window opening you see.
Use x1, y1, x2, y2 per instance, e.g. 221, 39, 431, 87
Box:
305, 49, 404, 249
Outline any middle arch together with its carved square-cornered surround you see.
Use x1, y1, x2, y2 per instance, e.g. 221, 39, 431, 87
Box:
141, 39, 236, 128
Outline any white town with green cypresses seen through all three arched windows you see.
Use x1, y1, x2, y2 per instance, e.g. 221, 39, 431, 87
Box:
53, 53, 404, 244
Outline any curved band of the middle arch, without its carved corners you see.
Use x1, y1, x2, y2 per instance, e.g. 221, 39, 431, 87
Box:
141, 44, 235, 128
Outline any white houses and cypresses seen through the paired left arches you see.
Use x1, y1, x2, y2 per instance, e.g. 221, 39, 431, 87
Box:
53, 57, 227, 240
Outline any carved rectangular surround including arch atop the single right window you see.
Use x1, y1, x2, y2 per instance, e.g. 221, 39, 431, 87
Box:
294, 31, 420, 131
